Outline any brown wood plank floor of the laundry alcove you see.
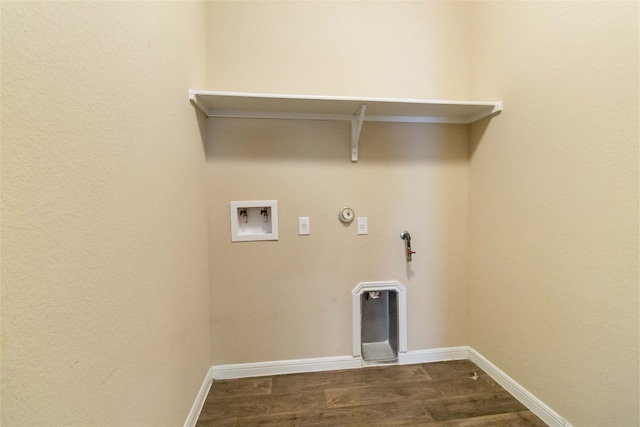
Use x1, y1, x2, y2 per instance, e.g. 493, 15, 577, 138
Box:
196, 360, 546, 427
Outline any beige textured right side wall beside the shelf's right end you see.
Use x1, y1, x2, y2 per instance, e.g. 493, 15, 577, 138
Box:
469, 2, 640, 426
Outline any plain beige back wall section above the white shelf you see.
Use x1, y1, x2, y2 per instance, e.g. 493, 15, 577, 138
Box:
207, 1, 472, 99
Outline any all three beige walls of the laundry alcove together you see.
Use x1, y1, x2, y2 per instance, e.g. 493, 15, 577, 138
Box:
1, 2, 640, 425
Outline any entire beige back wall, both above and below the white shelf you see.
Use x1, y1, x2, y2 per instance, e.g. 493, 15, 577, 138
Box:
207, 2, 471, 364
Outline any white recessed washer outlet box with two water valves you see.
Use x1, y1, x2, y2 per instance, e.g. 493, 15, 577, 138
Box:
231, 200, 278, 242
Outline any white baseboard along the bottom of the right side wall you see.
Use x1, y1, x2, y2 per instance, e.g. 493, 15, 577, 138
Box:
469, 347, 572, 427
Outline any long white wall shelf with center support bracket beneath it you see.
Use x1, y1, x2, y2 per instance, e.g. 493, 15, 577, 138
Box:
189, 89, 502, 162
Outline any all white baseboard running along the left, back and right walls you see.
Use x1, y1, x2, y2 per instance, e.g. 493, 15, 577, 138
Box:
190, 346, 572, 427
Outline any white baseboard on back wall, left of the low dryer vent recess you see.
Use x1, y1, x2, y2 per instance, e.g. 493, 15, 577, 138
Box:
211, 356, 361, 379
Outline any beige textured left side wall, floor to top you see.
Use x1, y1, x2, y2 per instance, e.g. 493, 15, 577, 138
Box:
1, 1, 210, 426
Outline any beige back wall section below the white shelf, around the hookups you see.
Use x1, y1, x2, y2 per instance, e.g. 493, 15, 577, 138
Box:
207, 119, 469, 364
